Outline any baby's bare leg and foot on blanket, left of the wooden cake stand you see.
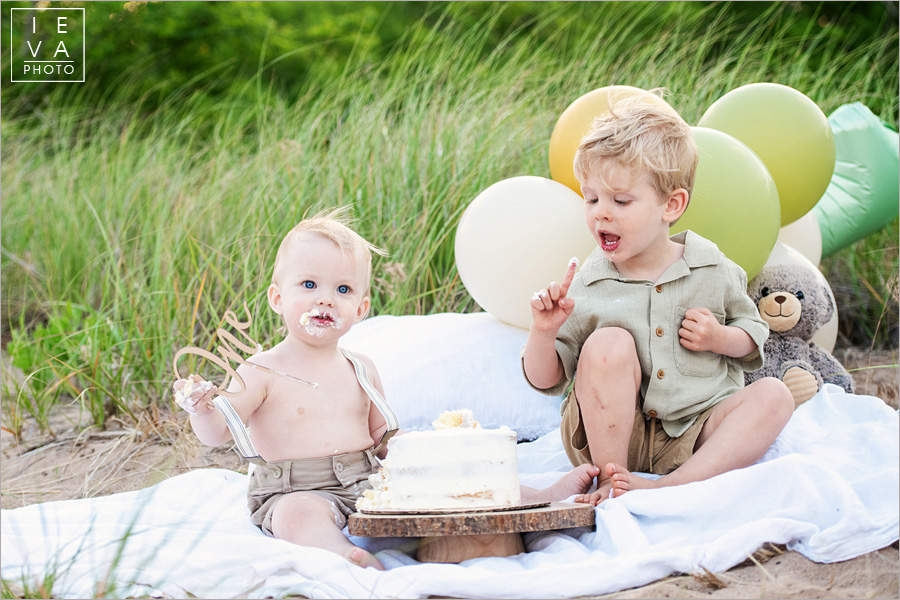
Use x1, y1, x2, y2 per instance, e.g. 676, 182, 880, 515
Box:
272, 492, 384, 571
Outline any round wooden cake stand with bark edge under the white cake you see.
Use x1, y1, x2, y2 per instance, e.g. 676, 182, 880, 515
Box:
347, 502, 594, 563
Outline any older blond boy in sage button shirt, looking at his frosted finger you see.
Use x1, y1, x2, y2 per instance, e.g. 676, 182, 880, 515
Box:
523, 99, 793, 504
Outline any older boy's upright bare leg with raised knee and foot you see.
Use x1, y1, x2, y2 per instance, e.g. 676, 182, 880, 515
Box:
575, 327, 641, 504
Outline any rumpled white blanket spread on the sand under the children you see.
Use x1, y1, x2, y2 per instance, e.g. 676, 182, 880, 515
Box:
0, 386, 900, 598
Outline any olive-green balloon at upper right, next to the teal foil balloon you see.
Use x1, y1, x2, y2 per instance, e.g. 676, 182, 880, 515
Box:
699, 83, 835, 225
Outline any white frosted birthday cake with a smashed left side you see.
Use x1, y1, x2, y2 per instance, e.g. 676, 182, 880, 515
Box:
357, 410, 521, 511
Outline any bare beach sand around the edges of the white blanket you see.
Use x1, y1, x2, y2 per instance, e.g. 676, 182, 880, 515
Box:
0, 350, 900, 598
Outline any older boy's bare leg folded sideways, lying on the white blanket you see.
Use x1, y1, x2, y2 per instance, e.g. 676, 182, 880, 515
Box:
604, 377, 794, 496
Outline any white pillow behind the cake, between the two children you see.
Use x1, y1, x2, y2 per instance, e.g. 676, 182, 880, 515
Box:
341, 313, 562, 440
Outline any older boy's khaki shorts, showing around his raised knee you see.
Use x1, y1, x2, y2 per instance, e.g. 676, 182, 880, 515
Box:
559, 389, 715, 475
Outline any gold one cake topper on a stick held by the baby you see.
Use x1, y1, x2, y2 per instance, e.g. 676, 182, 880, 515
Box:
172, 302, 319, 398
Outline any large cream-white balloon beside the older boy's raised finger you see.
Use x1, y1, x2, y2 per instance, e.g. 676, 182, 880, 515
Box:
455, 176, 597, 329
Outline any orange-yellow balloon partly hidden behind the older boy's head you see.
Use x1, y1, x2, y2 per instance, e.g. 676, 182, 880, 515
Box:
549, 85, 677, 195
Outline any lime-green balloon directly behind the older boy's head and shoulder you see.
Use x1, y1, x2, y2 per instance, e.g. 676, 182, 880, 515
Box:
670, 127, 781, 280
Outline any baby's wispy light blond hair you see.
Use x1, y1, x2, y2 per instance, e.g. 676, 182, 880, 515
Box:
272, 206, 385, 295
